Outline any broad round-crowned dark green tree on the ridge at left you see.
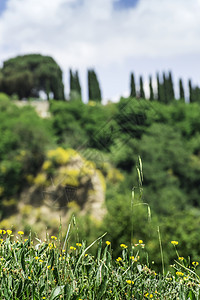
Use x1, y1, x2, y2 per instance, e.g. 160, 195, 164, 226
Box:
0, 54, 64, 100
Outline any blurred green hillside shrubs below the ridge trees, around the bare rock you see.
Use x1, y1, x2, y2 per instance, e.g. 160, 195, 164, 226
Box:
0, 89, 200, 271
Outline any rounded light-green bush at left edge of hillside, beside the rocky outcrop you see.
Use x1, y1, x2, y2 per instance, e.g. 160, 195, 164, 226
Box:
0, 101, 53, 212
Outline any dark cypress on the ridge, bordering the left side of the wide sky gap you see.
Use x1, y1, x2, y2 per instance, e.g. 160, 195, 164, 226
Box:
88, 69, 101, 102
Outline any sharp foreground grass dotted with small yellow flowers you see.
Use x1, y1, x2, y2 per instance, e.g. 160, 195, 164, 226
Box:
0, 230, 200, 300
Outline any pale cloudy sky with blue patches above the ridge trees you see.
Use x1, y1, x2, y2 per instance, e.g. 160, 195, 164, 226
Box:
0, 0, 200, 102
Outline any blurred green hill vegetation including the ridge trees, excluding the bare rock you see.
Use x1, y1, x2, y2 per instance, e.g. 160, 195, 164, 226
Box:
0, 55, 200, 278
